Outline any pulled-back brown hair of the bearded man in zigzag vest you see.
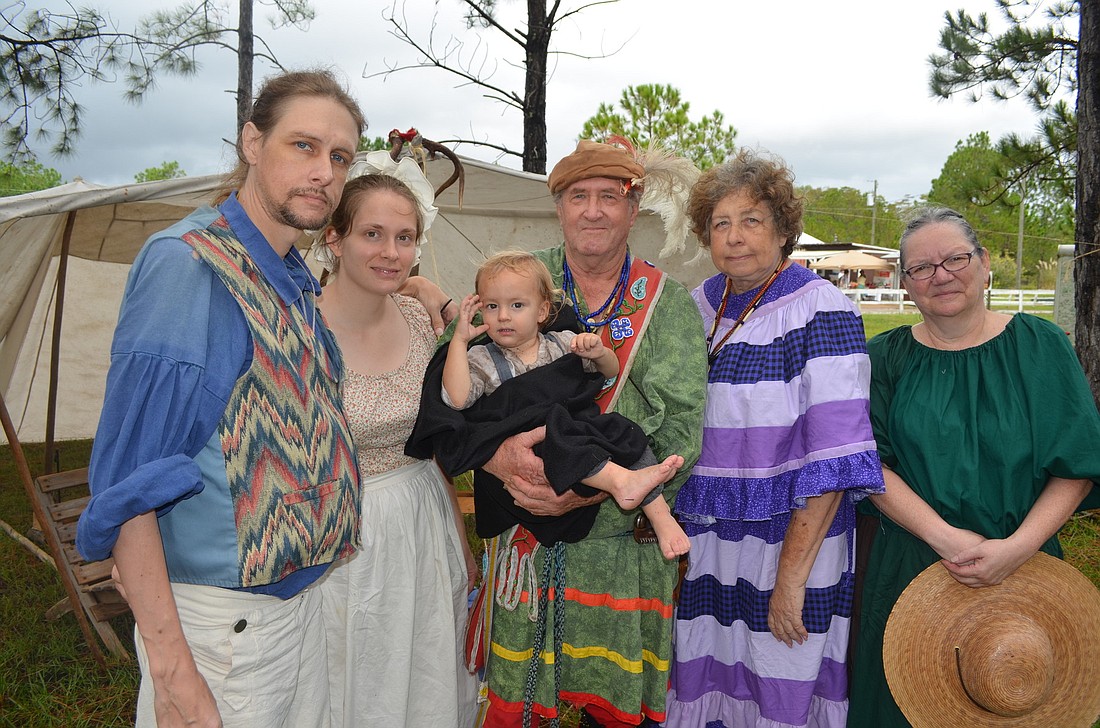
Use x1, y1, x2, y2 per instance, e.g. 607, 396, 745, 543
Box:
215, 68, 366, 202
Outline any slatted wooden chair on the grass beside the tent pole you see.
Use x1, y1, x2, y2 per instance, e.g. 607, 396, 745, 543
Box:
30, 467, 131, 664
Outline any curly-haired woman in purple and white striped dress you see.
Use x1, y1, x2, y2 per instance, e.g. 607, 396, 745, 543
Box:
667, 151, 882, 728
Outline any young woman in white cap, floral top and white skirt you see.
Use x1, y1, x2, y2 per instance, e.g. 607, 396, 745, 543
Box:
318, 159, 476, 728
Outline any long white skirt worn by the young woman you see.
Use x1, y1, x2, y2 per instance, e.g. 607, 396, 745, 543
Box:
320, 461, 476, 728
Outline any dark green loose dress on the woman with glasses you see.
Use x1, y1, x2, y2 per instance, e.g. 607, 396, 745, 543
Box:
848, 313, 1100, 728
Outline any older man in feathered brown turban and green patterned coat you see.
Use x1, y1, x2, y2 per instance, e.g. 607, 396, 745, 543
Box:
484, 141, 706, 728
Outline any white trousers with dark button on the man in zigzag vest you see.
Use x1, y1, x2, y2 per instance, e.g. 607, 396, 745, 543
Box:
134, 584, 329, 728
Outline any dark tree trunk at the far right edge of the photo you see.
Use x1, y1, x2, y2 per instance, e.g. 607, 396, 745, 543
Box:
1074, 2, 1100, 402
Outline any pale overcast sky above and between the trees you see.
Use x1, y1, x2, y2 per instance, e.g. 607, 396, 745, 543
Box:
31, 0, 1036, 200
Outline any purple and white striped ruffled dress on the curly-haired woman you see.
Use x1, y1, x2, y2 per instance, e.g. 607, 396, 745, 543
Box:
666, 265, 883, 728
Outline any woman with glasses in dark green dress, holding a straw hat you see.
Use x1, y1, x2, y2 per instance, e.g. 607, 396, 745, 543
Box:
848, 208, 1100, 728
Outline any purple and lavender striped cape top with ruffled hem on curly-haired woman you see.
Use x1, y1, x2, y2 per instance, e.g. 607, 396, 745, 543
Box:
677, 266, 883, 521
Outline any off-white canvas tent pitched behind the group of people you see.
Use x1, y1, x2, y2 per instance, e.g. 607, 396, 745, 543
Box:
0, 158, 712, 448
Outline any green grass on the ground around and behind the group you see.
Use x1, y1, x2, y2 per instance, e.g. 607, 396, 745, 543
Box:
0, 313, 1100, 728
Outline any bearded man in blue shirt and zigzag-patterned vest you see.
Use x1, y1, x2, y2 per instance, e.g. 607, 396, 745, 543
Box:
78, 71, 364, 728
